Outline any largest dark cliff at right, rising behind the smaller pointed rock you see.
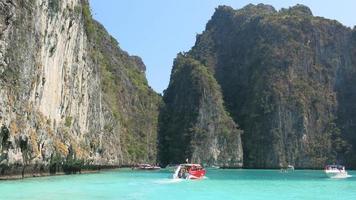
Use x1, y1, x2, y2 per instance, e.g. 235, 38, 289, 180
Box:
169, 4, 356, 168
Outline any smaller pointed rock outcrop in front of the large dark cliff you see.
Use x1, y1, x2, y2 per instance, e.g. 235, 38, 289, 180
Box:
159, 54, 243, 167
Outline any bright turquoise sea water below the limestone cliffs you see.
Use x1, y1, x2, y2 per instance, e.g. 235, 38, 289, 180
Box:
0, 169, 356, 200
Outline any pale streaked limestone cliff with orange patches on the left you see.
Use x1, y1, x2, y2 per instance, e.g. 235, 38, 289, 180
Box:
0, 0, 160, 175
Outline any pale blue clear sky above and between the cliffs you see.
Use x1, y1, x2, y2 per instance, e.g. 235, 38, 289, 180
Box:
90, 0, 356, 93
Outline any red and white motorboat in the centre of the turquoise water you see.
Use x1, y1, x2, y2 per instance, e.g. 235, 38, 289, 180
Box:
173, 164, 206, 179
